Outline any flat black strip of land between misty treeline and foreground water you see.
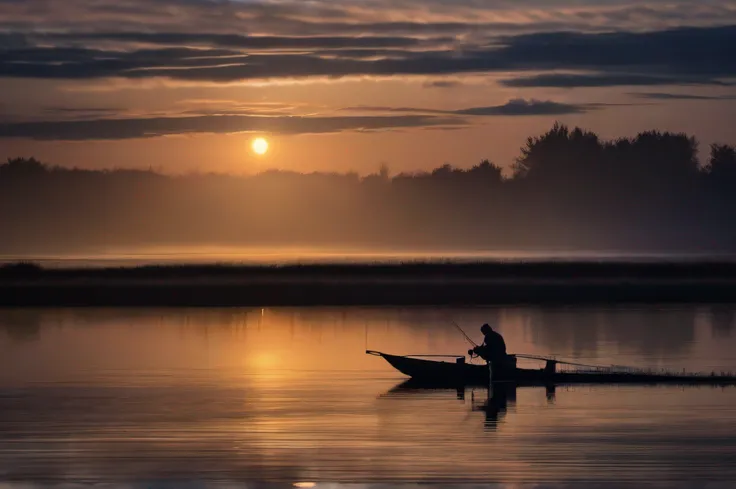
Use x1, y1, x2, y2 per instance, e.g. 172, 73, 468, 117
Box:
0, 262, 736, 307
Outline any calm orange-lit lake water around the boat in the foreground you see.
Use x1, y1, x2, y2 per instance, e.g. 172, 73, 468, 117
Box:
0, 306, 736, 488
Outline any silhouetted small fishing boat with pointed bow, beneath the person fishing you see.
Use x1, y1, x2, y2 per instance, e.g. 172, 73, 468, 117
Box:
366, 350, 736, 386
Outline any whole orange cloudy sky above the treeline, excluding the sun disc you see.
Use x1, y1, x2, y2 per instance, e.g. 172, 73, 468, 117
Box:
0, 0, 736, 174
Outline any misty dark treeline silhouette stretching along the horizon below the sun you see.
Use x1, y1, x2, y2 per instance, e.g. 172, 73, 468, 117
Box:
0, 124, 736, 254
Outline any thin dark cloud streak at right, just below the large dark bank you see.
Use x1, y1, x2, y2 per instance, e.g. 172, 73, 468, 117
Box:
499, 73, 730, 88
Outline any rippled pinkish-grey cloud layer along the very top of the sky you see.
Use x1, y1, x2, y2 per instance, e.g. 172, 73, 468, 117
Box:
0, 0, 736, 36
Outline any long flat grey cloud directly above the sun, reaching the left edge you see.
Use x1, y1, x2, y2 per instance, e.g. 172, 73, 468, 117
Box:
0, 115, 464, 141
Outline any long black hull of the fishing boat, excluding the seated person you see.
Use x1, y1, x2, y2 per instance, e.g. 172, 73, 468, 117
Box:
372, 352, 736, 386
